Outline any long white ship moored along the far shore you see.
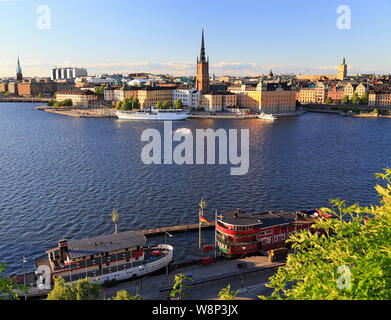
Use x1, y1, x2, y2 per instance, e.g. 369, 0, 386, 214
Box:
116, 109, 190, 121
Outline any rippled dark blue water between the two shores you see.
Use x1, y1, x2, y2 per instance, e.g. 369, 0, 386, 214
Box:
0, 103, 391, 274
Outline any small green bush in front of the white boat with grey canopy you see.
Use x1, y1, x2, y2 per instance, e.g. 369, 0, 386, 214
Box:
47, 277, 101, 300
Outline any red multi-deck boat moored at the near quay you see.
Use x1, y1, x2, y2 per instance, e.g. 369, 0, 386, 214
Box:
216, 209, 324, 257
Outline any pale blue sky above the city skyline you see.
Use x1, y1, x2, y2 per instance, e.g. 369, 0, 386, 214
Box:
0, 0, 391, 77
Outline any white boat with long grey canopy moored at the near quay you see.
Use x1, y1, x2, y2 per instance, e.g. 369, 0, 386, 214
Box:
15, 231, 174, 296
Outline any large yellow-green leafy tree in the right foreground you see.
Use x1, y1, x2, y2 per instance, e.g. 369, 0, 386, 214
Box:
261, 168, 391, 300
